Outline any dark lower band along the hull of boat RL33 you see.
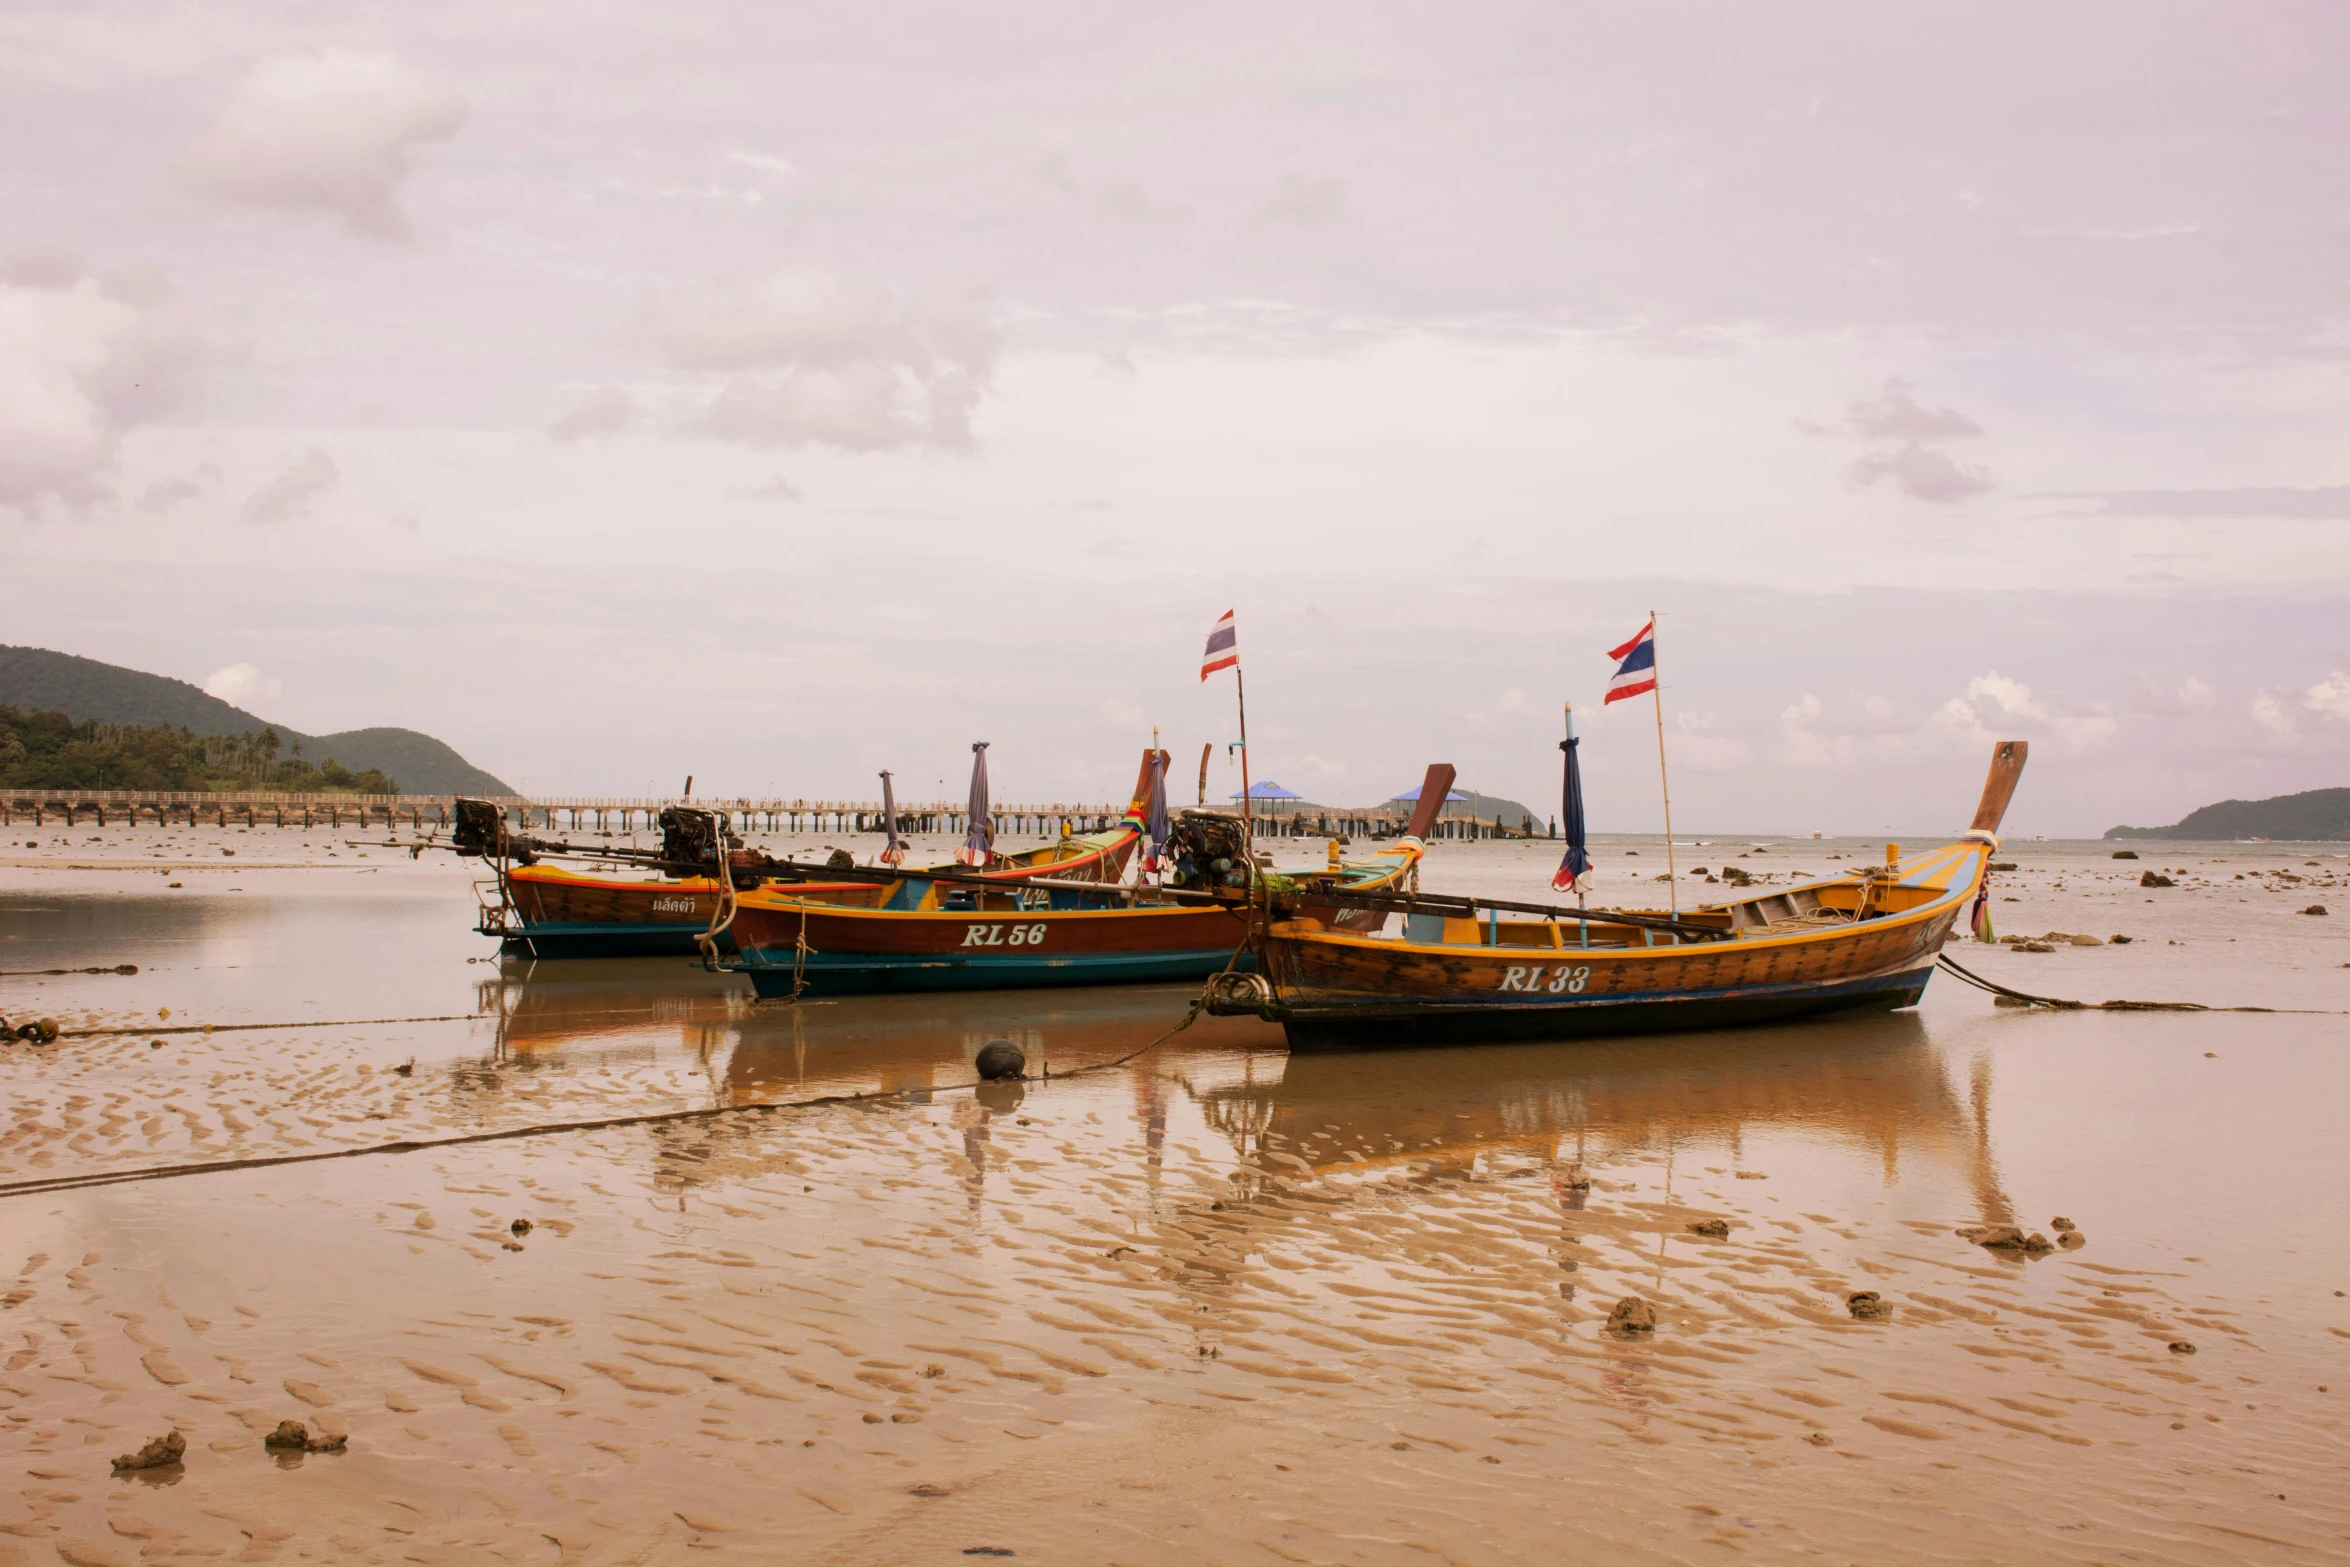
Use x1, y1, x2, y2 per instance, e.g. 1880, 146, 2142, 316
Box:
1274, 963, 1934, 1052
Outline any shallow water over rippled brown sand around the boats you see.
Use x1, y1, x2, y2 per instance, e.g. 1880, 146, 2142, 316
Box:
0, 827, 2350, 1562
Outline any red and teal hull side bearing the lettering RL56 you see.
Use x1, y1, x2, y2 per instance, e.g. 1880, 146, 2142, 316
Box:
733, 902, 1248, 996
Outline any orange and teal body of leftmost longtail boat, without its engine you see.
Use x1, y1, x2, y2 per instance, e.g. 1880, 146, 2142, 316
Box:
479, 754, 1170, 959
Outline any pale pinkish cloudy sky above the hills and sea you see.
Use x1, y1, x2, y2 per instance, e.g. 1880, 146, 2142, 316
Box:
0, 0, 2350, 836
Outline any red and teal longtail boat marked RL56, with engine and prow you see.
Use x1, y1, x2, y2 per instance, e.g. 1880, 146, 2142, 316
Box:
733, 754, 1452, 998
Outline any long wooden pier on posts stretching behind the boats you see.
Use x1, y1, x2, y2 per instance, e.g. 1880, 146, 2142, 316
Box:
0, 789, 1544, 839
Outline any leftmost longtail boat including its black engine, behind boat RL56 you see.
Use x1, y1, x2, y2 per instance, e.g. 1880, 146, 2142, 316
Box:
458, 754, 1152, 959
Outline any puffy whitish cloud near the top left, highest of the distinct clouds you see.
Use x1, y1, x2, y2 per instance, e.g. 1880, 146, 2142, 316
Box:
181, 49, 465, 240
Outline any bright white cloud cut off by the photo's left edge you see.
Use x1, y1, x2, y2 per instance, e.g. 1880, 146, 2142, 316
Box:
0, 249, 214, 507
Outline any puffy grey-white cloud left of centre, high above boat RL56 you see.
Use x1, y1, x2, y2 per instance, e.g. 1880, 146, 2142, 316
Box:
649, 268, 996, 451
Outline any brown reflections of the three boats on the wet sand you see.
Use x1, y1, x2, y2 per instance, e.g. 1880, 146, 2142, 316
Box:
484, 961, 2012, 1224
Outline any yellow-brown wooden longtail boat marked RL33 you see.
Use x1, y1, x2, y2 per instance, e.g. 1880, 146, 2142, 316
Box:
1208, 740, 2026, 1050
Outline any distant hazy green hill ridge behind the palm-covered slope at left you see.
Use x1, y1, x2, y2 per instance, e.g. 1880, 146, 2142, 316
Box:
0, 646, 512, 794
